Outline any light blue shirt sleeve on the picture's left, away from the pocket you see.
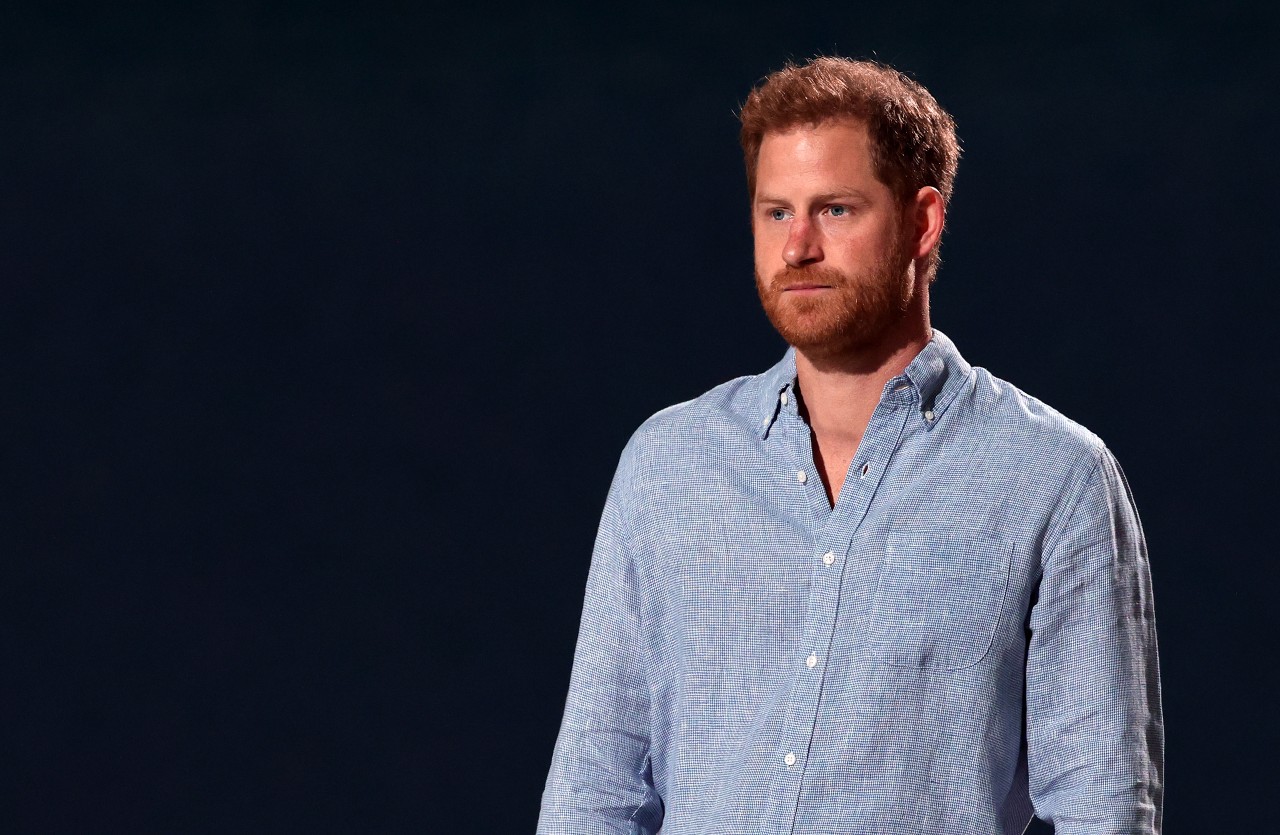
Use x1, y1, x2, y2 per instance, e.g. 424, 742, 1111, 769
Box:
538, 439, 662, 835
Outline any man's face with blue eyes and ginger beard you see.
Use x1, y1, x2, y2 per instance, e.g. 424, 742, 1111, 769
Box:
751, 120, 915, 359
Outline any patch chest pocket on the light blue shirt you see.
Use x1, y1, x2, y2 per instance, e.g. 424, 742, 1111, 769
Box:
869, 529, 1012, 670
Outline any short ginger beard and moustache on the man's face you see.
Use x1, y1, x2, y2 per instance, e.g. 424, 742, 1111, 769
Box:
755, 233, 915, 360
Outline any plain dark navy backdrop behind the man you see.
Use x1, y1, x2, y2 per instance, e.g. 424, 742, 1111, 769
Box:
0, 1, 1280, 832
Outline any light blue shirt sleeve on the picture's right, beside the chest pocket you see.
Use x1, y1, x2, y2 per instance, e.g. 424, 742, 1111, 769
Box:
1027, 450, 1165, 835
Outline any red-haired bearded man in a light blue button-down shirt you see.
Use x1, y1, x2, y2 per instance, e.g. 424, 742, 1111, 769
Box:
539, 58, 1164, 835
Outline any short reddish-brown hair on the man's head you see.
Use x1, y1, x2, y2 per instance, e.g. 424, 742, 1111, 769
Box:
739, 56, 960, 205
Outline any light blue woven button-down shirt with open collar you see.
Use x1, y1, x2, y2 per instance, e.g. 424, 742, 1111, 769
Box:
538, 332, 1164, 835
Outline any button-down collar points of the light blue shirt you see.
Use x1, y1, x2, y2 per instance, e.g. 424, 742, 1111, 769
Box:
755, 329, 973, 438
